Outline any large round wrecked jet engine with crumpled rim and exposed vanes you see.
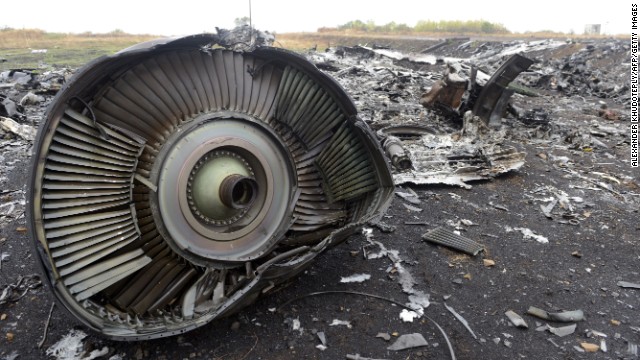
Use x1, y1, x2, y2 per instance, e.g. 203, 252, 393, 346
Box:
27, 34, 394, 340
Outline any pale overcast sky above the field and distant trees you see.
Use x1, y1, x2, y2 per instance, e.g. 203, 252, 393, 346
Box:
0, 0, 637, 35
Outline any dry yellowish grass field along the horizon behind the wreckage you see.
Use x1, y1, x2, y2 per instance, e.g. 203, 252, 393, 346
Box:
0, 29, 624, 71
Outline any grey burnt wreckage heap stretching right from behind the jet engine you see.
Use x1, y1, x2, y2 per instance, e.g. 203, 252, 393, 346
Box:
309, 39, 630, 186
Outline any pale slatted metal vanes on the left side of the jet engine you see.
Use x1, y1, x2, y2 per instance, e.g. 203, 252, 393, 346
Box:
42, 109, 151, 301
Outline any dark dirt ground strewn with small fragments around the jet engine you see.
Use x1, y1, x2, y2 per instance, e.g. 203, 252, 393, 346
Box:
0, 34, 640, 360
